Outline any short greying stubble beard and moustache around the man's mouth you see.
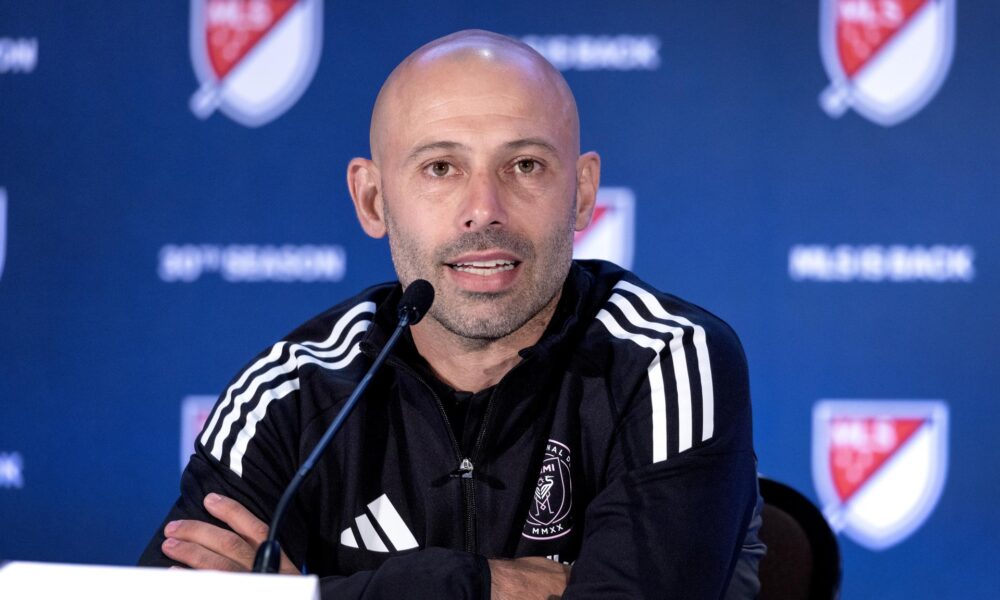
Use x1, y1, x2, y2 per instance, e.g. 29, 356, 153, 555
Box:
382, 195, 573, 347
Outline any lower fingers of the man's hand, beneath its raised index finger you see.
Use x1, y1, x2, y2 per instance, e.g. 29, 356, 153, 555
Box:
161, 520, 256, 571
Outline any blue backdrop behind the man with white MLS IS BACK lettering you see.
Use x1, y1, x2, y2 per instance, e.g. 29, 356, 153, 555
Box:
0, 0, 1000, 599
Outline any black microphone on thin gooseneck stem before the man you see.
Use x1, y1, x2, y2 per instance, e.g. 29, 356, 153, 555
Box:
253, 279, 434, 573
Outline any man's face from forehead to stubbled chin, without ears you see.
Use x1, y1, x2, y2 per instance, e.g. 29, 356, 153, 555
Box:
378, 54, 589, 340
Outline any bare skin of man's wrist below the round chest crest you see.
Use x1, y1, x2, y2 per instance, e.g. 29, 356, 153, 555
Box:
490, 556, 570, 600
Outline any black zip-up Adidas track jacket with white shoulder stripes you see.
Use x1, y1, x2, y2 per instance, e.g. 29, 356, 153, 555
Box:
140, 261, 757, 599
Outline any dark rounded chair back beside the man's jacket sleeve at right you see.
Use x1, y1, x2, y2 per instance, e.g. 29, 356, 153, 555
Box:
758, 477, 841, 600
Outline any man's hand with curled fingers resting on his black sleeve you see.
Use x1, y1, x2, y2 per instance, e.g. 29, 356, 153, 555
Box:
161, 494, 300, 575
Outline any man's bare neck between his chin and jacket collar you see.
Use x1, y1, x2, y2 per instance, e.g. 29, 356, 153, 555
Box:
410, 293, 561, 392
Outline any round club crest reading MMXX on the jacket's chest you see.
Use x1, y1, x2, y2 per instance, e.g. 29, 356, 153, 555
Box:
522, 440, 573, 541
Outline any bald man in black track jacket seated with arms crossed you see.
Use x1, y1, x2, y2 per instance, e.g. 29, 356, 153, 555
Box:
141, 31, 757, 598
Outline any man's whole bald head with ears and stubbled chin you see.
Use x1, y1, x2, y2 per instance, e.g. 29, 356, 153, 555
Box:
347, 31, 600, 354
